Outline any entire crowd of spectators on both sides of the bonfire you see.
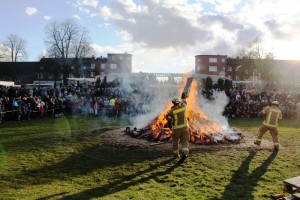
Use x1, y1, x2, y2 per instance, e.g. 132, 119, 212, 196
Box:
0, 81, 300, 123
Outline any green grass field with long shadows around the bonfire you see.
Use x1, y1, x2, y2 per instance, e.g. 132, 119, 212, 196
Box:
0, 117, 300, 200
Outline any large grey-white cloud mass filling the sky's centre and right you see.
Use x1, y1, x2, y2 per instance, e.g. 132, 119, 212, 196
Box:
72, 0, 300, 72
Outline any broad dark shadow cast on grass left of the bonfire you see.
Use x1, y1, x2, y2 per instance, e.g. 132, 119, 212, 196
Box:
21, 145, 168, 184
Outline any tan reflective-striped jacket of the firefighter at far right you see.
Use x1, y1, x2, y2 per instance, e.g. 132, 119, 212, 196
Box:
263, 106, 282, 128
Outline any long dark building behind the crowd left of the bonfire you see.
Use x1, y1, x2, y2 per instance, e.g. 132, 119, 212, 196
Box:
0, 53, 132, 85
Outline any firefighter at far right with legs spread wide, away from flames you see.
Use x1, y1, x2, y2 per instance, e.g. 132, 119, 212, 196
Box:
254, 101, 282, 151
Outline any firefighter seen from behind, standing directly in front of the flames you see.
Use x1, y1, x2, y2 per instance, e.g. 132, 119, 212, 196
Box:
167, 97, 190, 164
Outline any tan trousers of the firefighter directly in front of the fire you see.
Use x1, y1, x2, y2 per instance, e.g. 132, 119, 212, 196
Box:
172, 127, 190, 157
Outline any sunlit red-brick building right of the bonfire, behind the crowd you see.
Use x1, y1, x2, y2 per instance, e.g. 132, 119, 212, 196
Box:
195, 55, 300, 88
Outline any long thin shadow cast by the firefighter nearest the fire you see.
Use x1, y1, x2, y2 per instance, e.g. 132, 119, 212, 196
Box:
62, 159, 178, 200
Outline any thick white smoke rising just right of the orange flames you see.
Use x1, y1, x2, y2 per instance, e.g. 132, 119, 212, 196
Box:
198, 91, 232, 132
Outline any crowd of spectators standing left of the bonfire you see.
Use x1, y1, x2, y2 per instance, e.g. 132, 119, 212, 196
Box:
0, 81, 152, 123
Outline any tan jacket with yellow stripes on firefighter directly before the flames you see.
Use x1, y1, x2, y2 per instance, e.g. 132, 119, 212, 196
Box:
167, 105, 188, 129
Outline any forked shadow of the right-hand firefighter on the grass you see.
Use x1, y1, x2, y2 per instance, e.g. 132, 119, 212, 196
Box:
220, 151, 277, 200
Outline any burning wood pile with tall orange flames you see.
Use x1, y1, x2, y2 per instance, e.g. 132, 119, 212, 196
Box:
125, 78, 241, 144
